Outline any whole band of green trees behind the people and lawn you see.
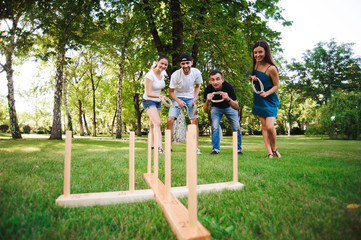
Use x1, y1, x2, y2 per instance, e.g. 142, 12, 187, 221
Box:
0, 0, 360, 139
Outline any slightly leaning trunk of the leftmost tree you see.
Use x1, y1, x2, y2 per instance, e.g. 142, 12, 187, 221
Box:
5, 47, 22, 139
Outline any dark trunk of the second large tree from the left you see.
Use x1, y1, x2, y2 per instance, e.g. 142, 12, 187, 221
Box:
49, 45, 65, 140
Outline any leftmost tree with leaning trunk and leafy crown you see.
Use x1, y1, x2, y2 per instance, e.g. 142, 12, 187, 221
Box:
0, 0, 36, 139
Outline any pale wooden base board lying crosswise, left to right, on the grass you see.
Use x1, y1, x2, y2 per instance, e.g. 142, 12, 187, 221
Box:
55, 180, 244, 207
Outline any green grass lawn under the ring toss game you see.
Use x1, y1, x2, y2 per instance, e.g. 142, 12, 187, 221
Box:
0, 135, 361, 239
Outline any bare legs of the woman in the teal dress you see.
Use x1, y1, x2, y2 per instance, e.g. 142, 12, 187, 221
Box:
259, 117, 281, 157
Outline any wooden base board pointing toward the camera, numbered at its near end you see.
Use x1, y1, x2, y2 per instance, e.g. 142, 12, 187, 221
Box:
143, 173, 211, 240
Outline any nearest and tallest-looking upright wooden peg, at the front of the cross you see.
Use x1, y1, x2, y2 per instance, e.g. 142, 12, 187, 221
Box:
187, 124, 198, 230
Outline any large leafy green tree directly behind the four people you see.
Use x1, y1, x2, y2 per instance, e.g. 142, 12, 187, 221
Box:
131, 0, 290, 141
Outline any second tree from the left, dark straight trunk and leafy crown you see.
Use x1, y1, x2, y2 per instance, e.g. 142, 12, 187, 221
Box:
38, 0, 99, 140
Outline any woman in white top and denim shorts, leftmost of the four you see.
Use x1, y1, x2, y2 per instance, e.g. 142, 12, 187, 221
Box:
143, 56, 169, 153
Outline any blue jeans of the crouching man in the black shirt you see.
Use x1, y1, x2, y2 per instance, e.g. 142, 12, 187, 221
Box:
211, 107, 242, 152
